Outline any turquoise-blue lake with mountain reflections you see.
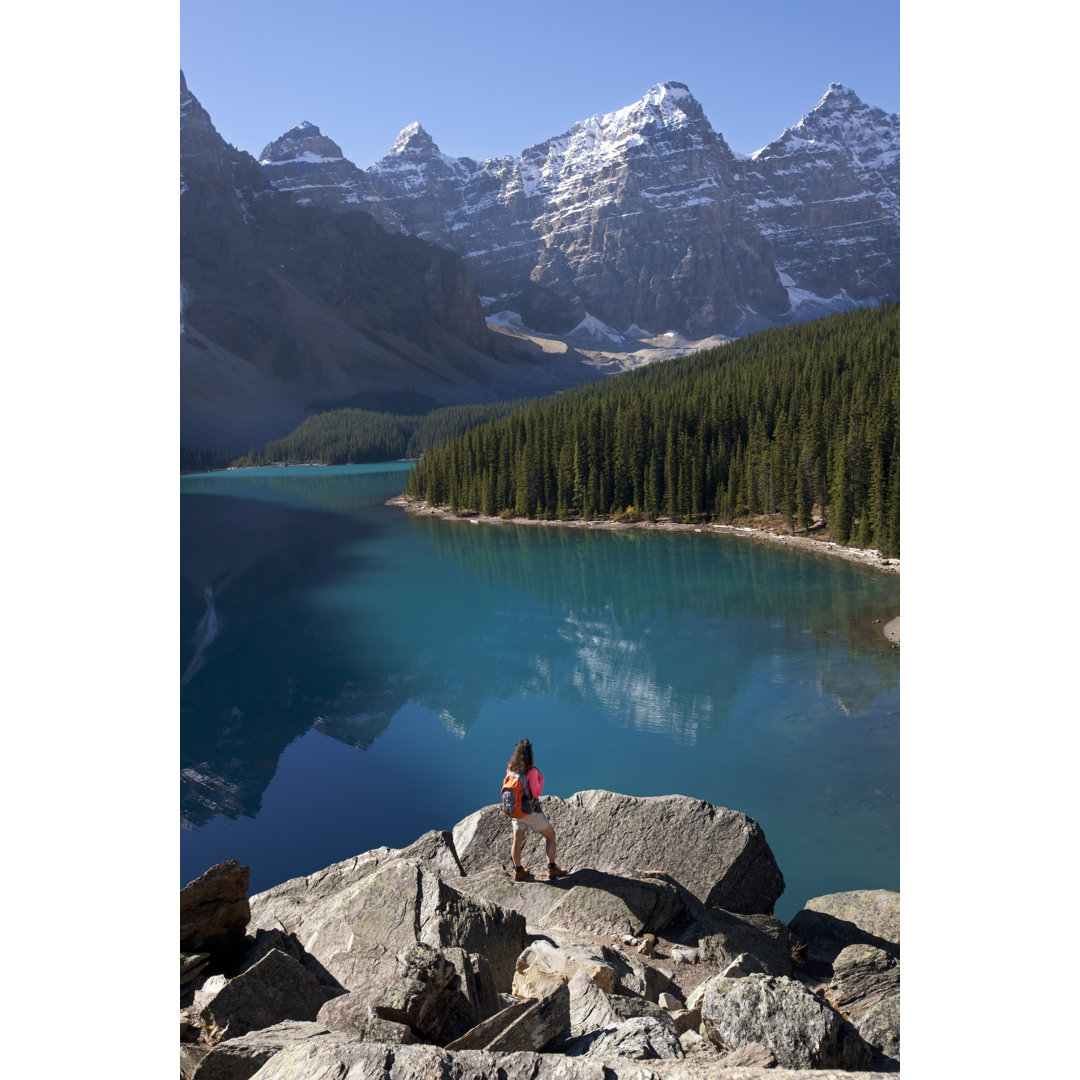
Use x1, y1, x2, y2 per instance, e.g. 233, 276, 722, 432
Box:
180, 463, 900, 920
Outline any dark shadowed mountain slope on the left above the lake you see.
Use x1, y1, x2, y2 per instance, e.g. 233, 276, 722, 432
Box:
180, 72, 597, 455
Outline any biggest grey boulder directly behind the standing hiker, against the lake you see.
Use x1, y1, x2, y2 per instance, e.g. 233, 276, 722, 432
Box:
454, 791, 784, 915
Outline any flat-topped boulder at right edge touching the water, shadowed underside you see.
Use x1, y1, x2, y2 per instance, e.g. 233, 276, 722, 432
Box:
788, 889, 900, 963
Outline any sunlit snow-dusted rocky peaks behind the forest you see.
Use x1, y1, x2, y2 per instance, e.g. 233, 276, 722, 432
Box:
260, 82, 900, 339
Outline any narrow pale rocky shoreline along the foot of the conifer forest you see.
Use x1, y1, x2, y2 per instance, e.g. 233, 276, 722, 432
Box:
386, 495, 900, 648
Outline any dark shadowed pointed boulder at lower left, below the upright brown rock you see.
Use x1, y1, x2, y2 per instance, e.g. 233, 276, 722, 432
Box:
195, 949, 340, 1042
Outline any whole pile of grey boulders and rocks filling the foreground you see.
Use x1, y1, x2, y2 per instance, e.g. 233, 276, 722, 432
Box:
180, 791, 900, 1080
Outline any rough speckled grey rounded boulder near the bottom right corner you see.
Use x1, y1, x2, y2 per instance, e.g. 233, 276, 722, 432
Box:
701, 975, 873, 1070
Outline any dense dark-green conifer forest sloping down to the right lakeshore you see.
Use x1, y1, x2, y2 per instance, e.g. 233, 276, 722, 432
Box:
407, 305, 900, 556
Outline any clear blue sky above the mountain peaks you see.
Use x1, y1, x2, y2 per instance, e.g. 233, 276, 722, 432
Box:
179, 0, 900, 167
